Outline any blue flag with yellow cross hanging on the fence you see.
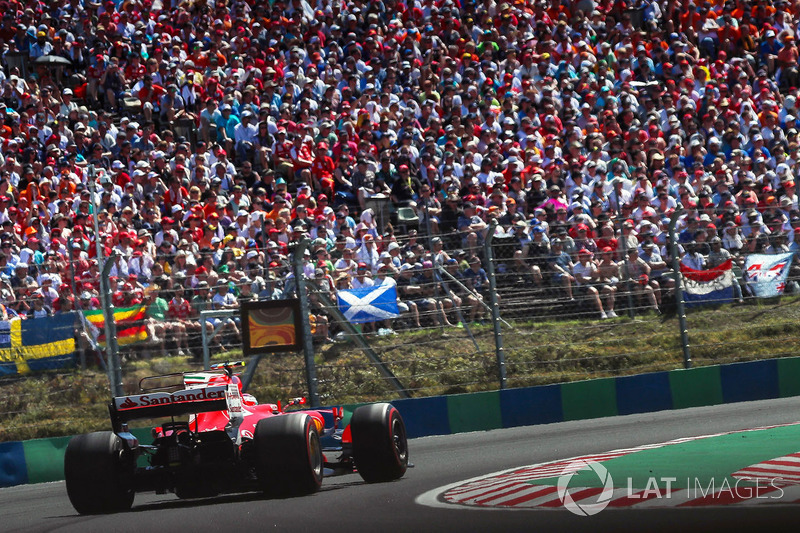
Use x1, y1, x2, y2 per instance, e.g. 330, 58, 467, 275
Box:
0, 313, 75, 376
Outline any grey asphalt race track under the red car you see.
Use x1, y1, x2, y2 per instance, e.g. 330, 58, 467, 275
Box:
0, 398, 800, 533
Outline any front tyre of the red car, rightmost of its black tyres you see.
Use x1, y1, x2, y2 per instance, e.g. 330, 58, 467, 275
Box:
350, 403, 408, 483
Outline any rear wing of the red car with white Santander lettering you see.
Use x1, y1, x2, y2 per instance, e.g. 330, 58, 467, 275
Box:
109, 385, 228, 431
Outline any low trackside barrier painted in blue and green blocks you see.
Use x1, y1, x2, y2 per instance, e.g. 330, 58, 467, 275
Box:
0, 357, 800, 487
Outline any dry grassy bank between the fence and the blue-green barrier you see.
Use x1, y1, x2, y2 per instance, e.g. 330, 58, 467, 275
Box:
0, 298, 800, 442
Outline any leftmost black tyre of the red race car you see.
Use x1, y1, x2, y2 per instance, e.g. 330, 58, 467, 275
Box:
64, 431, 135, 514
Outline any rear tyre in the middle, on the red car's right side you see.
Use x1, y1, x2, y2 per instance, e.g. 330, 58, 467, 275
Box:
254, 413, 323, 497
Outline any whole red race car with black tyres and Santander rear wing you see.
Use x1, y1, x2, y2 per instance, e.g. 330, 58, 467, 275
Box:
64, 362, 408, 514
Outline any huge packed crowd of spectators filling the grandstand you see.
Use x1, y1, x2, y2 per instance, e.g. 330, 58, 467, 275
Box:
0, 0, 800, 349
